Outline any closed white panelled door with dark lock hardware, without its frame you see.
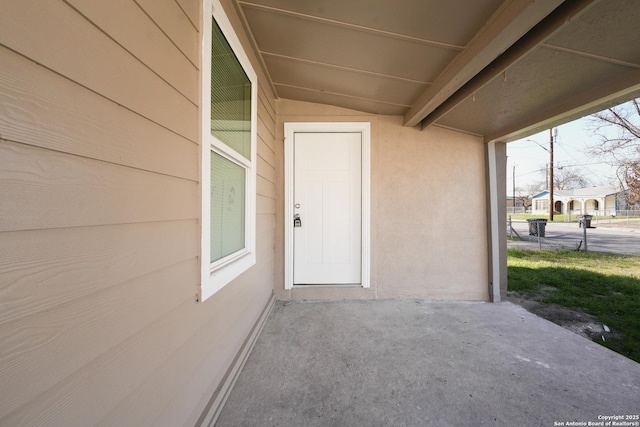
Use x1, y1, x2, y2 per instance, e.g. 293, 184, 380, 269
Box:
291, 132, 362, 285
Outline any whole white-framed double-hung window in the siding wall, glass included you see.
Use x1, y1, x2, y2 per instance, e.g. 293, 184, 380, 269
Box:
201, 0, 257, 300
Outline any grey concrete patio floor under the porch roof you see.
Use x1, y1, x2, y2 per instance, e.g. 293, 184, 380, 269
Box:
216, 300, 640, 427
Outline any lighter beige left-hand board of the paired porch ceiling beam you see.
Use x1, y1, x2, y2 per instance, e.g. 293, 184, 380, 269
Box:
404, 0, 564, 126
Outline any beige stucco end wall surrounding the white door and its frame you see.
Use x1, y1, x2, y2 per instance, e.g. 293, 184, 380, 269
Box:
275, 99, 488, 300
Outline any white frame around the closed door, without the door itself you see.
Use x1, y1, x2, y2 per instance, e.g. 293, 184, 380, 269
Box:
284, 122, 371, 289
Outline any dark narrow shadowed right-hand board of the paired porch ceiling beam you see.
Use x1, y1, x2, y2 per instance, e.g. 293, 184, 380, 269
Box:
422, 0, 600, 129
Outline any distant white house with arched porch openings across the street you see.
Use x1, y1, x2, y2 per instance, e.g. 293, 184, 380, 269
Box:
531, 187, 626, 215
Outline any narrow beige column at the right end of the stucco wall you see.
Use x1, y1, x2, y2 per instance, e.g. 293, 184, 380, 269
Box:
485, 142, 507, 302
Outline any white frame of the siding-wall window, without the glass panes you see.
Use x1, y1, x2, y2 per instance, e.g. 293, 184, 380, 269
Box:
200, 0, 258, 301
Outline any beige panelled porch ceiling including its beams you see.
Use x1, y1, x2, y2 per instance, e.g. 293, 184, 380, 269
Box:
235, 0, 640, 141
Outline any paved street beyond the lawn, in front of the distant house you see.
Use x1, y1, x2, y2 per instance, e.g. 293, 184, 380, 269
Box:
507, 220, 640, 255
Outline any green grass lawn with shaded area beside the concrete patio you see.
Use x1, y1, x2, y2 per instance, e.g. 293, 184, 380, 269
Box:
507, 249, 640, 362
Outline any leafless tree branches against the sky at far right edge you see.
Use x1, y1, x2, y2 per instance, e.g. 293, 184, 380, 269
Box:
589, 98, 640, 203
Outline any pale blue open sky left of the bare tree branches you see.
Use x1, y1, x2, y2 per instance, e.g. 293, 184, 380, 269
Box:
507, 113, 615, 196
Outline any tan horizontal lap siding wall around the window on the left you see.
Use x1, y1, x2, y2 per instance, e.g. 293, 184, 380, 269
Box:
0, 0, 277, 426
